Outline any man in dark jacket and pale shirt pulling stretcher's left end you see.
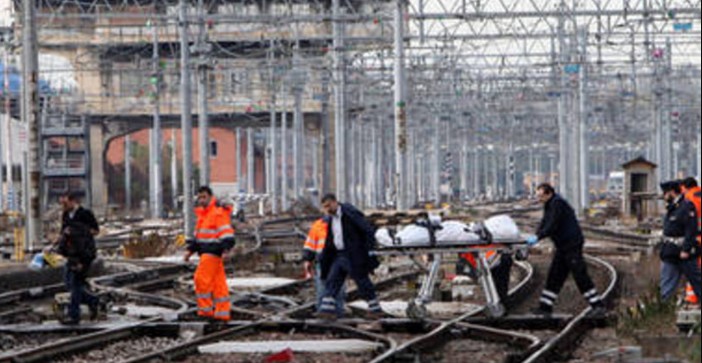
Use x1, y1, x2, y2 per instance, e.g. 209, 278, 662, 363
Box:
319, 194, 383, 320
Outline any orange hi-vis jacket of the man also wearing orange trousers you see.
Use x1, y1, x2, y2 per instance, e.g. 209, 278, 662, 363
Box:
188, 198, 235, 256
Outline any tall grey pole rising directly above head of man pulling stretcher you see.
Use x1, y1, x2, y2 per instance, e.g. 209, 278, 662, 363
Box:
332, 0, 348, 200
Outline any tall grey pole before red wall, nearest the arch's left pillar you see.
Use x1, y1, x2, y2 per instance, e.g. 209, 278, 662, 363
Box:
149, 22, 163, 218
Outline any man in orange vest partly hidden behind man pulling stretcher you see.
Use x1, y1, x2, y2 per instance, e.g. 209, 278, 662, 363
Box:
302, 218, 346, 318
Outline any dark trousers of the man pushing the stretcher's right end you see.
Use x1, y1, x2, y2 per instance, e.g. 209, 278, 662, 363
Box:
540, 248, 603, 310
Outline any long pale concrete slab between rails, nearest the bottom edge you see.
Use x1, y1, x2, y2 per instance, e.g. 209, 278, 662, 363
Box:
198, 339, 383, 354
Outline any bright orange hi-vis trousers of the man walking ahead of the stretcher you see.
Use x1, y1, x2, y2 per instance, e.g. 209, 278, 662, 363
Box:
195, 254, 231, 321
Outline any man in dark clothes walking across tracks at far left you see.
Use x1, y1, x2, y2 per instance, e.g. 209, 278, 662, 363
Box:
51, 193, 100, 325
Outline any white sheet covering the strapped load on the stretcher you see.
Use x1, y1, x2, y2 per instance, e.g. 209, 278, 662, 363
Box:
375, 216, 520, 248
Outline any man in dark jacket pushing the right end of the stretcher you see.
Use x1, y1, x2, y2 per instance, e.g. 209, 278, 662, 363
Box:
528, 184, 605, 315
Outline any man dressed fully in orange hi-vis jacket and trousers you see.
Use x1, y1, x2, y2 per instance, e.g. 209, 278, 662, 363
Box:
185, 186, 235, 321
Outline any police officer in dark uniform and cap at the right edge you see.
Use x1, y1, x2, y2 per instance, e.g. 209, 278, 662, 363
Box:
660, 181, 702, 300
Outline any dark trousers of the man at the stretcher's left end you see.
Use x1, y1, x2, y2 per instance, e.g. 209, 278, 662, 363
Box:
319, 252, 381, 314
